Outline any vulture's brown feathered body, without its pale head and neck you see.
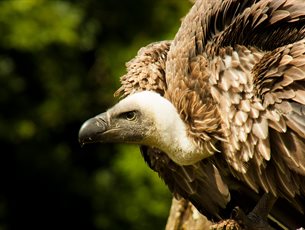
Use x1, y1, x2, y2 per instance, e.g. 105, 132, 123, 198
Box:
79, 0, 305, 228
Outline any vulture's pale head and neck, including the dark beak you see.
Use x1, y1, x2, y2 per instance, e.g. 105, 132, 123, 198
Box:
79, 91, 210, 165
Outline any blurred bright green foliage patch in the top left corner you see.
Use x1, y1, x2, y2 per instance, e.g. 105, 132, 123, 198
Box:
0, 0, 82, 51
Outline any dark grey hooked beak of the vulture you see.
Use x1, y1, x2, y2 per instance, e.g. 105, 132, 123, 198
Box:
78, 113, 109, 146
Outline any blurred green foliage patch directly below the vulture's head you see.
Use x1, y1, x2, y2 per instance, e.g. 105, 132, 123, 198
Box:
94, 146, 171, 229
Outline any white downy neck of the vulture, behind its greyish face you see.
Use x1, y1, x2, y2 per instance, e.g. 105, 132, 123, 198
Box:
141, 92, 211, 165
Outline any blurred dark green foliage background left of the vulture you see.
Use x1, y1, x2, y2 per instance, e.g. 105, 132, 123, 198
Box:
0, 0, 191, 230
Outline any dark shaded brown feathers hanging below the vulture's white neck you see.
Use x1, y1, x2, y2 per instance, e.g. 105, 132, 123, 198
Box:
140, 146, 230, 218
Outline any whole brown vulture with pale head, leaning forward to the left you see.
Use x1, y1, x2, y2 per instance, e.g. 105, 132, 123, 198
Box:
79, 0, 305, 229
